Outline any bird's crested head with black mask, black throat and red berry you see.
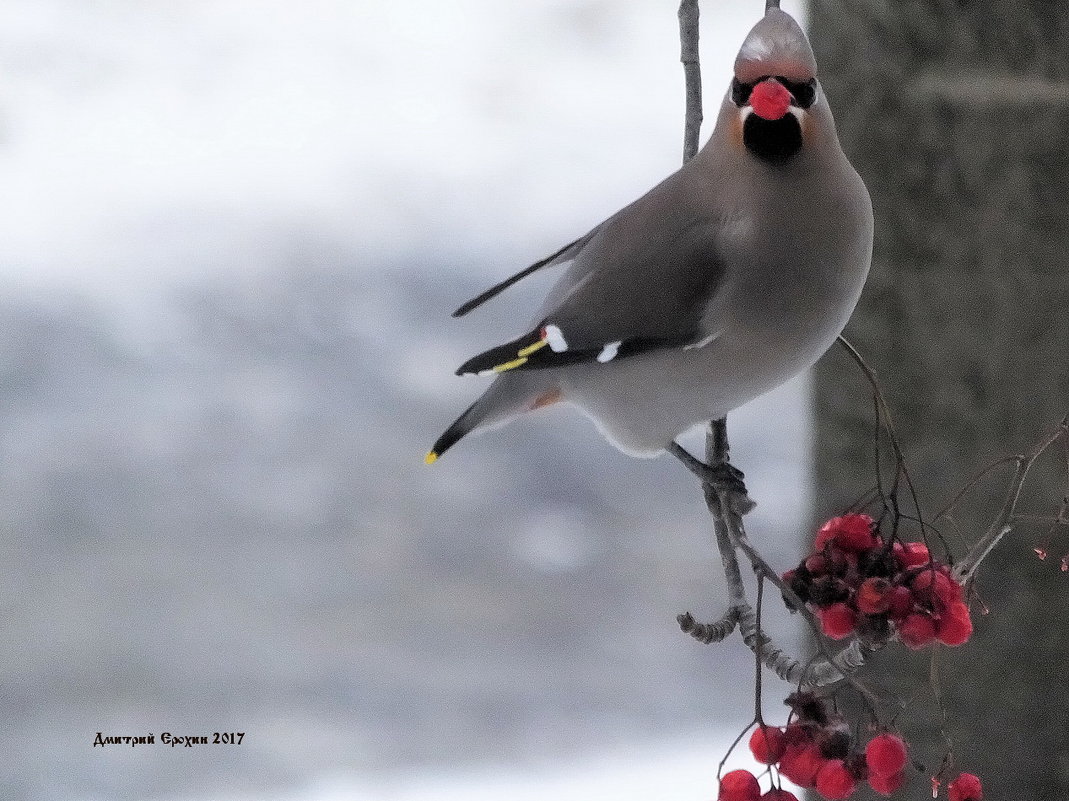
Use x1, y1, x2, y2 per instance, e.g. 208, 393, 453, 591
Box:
726, 9, 820, 163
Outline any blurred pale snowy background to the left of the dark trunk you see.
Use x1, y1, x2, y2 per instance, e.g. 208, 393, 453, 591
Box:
0, 0, 811, 801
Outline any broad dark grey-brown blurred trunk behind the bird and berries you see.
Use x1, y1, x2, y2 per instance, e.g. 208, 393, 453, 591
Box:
810, 0, 1069, 801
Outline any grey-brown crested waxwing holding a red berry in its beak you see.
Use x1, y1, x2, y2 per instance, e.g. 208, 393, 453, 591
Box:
424, 7, 873, 464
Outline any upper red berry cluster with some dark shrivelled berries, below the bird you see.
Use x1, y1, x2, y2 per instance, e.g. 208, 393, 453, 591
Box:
784, 514, 973, 650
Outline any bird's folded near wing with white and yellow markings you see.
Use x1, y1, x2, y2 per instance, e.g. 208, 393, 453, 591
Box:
456, 216, 725, 374
